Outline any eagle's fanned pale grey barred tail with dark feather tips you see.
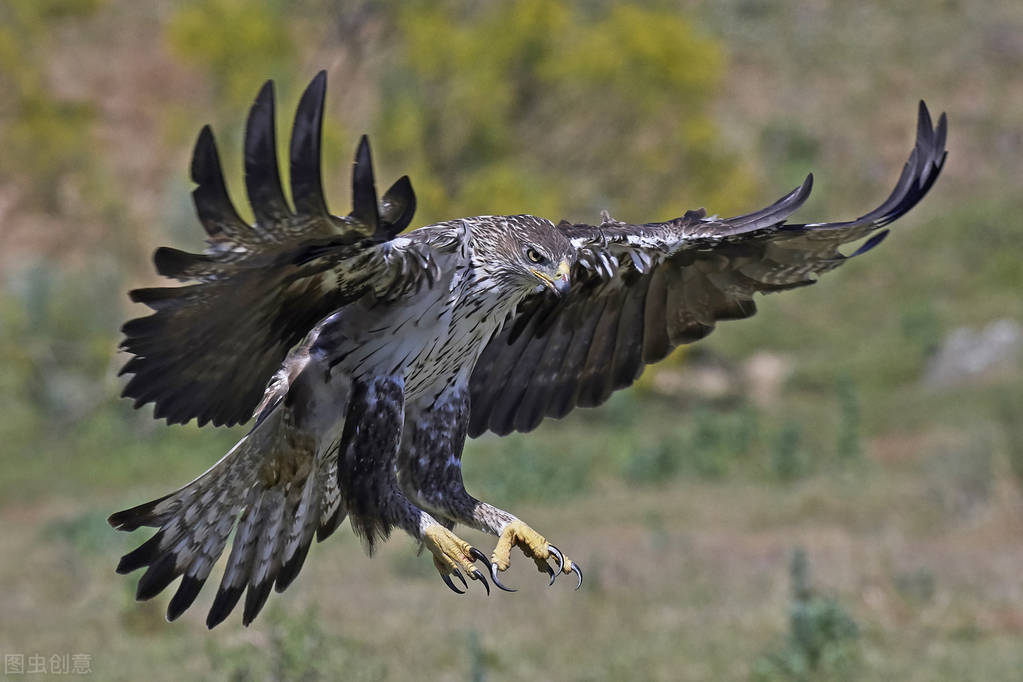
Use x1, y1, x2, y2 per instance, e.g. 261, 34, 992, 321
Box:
109, 402, 344, 628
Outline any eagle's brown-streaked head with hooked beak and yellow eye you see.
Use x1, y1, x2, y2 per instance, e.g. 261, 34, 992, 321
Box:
474, 216, 576, 295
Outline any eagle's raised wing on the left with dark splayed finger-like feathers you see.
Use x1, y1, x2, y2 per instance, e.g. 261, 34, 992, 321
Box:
121, 72, 437, 425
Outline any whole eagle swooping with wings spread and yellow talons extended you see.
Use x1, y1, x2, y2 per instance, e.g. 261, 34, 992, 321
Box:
109, 72, 946, 628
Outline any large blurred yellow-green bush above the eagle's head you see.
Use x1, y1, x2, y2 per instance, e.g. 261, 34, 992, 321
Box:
381, 0, 752, 221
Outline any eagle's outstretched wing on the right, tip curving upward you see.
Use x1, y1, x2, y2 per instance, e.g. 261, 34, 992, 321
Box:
469, 102, 946, 437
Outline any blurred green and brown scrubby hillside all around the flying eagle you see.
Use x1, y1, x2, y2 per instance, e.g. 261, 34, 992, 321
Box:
0, 0, 1023, 680
